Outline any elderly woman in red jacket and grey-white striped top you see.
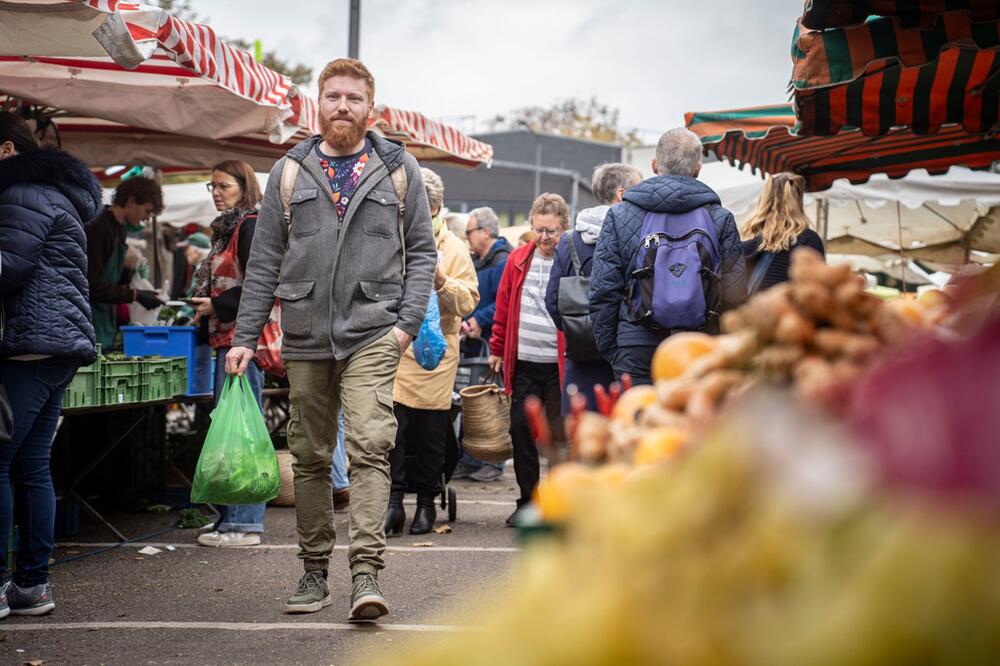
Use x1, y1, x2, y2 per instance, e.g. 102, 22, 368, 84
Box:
490, 192, 569, 526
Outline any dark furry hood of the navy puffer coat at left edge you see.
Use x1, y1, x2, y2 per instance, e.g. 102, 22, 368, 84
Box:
0, 148, 101, 223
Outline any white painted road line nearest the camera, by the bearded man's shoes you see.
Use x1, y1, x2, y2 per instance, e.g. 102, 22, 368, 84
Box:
3, 620, 475, 633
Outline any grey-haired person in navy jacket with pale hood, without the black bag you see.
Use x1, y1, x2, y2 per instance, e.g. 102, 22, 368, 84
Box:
545, 164, 642, 416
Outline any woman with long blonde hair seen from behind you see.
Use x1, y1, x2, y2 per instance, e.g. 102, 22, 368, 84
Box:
741, 173, 826, 296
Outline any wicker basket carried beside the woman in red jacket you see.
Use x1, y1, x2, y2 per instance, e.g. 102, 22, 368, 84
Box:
461, 384, 514, 463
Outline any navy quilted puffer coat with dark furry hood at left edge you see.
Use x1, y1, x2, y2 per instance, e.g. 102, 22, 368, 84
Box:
0, 149, 101, 364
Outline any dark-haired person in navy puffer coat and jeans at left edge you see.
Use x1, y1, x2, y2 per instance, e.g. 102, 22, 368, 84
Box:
0, 112, 101, 617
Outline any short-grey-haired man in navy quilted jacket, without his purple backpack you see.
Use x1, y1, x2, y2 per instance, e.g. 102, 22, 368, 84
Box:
590, 127, 746, 384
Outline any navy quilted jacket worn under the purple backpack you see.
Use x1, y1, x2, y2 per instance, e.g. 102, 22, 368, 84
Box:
590, 176, 747, 359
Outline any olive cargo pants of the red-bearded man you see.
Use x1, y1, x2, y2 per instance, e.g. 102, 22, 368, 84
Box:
285, 330, 400, 574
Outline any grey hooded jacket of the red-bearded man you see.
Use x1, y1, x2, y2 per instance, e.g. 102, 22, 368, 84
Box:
233, 132, 437, 360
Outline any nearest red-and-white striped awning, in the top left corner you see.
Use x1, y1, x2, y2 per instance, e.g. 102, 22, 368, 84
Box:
0, 0, 317, 142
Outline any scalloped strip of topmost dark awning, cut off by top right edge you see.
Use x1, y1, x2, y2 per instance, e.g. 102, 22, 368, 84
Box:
802, 0, 1000, 30
